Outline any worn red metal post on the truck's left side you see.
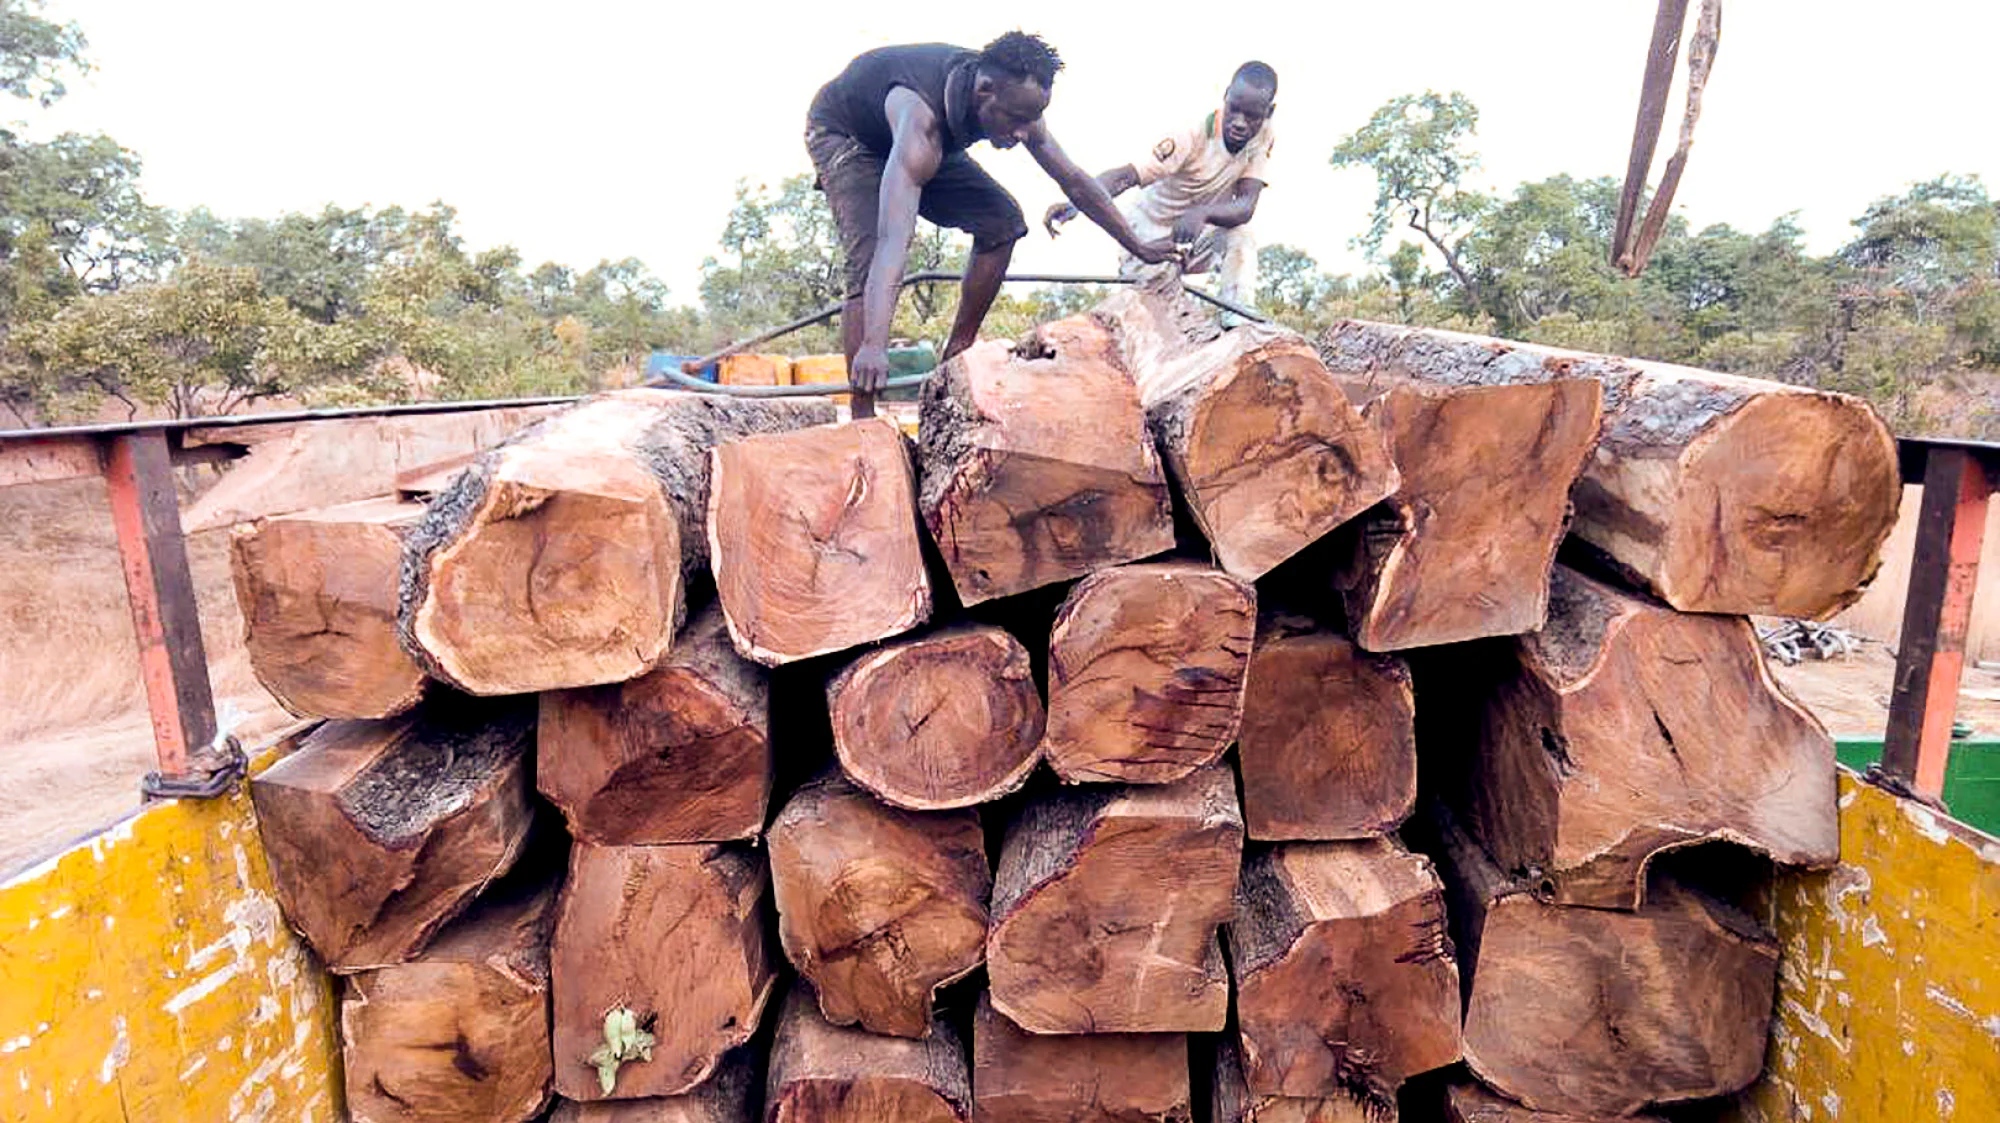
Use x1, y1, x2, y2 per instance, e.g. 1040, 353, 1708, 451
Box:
104, 430, 216, 775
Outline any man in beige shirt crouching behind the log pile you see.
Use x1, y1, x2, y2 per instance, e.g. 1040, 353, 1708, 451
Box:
1042, 62, 1278, 304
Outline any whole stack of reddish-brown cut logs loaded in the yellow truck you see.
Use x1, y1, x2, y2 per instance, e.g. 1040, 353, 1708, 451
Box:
234, 273, 1898, 1123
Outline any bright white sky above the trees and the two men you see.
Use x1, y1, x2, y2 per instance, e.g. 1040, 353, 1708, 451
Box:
23, 0, 2000, 300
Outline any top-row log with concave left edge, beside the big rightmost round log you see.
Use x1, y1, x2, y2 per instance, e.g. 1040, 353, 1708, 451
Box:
1320, 322, 1602, 651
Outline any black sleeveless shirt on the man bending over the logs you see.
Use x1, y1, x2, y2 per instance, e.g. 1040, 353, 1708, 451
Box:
806, 42, 986, 156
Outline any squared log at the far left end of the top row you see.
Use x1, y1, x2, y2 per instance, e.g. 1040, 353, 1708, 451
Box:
230, 491, 428, 717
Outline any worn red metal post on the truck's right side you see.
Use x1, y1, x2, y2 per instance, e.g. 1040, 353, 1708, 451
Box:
1882, 448, 1992, 799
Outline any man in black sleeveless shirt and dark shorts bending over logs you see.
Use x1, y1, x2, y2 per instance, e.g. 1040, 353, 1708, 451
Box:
806, 32, 1174, 416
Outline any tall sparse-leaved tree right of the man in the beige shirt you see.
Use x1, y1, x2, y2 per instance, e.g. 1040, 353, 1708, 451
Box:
1332, 90, 1488, 310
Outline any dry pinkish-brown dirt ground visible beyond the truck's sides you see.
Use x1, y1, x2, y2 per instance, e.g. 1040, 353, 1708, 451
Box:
0, 459, 2000, 877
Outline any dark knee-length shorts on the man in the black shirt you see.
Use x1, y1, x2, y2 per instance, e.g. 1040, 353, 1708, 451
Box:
806, 124, 1028, 300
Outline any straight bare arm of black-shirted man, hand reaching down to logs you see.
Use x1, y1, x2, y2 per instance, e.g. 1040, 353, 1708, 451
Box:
850, 86, 944, 390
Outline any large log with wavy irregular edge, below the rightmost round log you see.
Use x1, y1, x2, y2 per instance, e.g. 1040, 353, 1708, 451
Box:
1422, 565, 1840, 909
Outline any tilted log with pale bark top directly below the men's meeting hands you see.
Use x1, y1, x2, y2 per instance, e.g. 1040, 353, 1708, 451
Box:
1094, 276, 1398, 581
